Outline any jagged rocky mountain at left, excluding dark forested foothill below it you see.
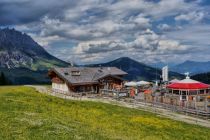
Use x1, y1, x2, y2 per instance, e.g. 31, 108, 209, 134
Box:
0, 28, 69, 70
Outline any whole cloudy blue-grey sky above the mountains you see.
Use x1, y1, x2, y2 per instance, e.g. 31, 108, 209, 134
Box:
0, 0, 210, 64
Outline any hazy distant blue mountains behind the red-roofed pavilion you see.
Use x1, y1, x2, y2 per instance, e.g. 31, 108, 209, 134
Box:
171, 61, 210, 74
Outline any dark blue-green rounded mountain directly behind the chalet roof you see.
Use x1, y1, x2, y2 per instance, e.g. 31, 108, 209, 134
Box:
89, 57, 183, 81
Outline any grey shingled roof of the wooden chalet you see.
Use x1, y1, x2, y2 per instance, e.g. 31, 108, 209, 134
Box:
51, 67, 127, 84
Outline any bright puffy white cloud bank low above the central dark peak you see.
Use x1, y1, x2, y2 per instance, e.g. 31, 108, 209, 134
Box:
72, 29, 189, 63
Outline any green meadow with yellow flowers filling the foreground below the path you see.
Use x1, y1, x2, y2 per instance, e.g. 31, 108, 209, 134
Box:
0, 86, 210, 140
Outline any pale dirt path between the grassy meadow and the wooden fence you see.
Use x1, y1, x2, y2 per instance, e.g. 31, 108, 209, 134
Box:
27, 85, 210, 128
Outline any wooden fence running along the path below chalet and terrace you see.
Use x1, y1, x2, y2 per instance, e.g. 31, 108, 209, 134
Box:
53, 90, 210, 120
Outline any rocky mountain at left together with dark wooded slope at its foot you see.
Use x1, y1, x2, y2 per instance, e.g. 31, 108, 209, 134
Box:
0, 28, 69, 84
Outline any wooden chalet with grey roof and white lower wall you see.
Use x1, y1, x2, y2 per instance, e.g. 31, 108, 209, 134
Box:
48, 67, 127, 94
